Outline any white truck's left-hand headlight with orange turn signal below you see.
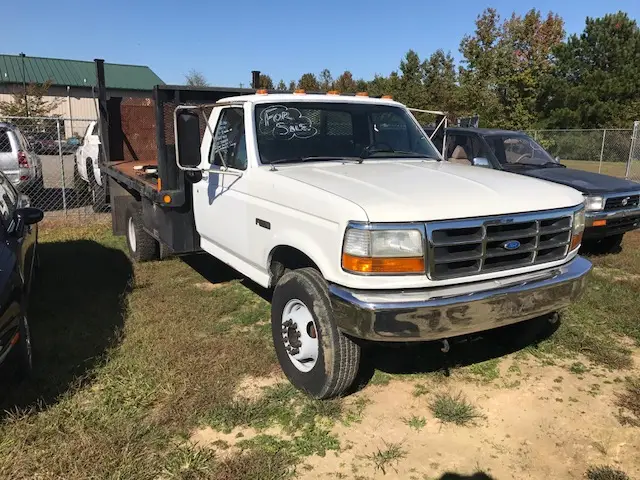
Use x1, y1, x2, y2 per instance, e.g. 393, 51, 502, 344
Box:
342, 226, 424, 274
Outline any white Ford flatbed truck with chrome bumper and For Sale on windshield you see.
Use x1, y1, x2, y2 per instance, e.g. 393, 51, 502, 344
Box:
97, 81, 591, 398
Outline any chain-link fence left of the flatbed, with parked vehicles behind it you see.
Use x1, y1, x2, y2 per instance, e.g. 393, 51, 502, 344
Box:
0, 117, 107, 217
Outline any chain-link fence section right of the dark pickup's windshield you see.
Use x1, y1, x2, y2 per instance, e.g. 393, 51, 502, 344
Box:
528, 128, 633, 177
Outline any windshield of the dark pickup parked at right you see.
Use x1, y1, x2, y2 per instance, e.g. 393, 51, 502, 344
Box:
485, 134, 560, 166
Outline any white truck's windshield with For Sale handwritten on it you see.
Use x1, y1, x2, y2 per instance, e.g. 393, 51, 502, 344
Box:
255, 102, 439, 164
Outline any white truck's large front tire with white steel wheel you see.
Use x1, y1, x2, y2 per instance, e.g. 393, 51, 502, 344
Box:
271, 268, 360, 399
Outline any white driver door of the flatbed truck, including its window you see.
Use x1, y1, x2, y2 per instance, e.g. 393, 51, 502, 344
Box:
193, 106, 250, 273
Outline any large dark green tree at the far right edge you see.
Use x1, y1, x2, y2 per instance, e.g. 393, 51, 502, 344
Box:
539, 12, 640, 128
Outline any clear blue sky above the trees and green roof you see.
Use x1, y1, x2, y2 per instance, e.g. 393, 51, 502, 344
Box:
0, 0, 640, 86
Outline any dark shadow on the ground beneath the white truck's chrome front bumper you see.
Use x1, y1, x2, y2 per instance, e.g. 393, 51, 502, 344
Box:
355, 315, 559, 388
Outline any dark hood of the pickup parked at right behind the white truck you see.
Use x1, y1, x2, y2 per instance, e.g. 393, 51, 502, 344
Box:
514, 167, 640, 194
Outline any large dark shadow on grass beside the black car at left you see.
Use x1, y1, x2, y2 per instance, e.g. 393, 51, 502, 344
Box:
0, 240, 133, 417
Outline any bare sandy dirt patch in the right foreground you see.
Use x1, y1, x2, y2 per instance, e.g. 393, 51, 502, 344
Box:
300, 358, 640, 480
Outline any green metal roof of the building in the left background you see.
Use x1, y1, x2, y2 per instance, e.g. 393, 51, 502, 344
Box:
0, 54, 164, 91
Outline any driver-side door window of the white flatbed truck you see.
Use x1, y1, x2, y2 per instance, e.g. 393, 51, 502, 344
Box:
209, 107, 247, 170
